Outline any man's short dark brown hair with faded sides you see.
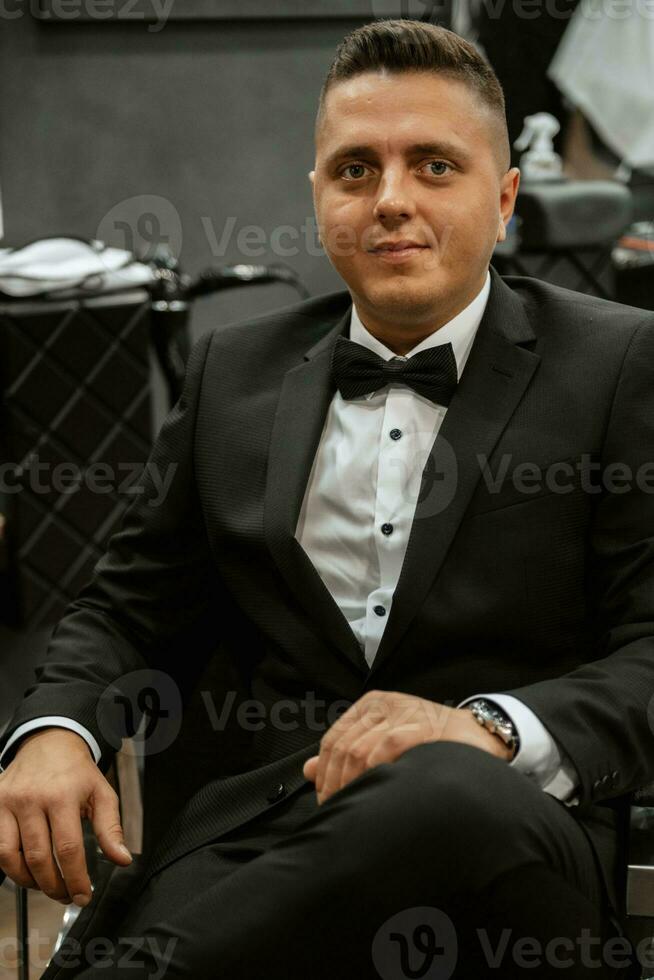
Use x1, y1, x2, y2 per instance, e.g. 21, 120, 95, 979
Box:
316, 19, 511, 168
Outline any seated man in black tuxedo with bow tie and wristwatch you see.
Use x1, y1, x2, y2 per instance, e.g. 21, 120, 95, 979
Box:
0, 15, 654, 980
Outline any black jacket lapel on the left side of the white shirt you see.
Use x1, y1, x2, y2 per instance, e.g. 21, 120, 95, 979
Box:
264, 306, 368, 676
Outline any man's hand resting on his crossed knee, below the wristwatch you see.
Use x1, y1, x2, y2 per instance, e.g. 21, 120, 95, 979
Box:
304, 691, 512, 803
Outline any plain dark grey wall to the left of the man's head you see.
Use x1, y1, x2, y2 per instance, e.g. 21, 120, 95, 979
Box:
0, 14, 371, 344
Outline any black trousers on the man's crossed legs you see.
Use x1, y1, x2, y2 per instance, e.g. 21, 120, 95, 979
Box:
48, 742, 632, 980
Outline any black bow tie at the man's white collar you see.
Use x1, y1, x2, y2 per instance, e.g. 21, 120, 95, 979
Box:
332, 335, 457, 405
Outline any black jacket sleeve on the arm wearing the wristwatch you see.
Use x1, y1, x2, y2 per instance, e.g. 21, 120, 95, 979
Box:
506, 316, 654, 808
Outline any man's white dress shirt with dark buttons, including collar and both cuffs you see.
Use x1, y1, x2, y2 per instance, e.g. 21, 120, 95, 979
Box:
0, 273, 579, 805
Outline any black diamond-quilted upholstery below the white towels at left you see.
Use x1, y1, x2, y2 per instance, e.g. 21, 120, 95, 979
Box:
0, 291, 152, 629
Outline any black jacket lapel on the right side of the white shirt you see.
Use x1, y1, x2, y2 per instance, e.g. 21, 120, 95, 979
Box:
366, 266, 540, 684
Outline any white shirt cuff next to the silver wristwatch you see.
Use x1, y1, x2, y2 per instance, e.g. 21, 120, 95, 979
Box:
457, 694, 579, 806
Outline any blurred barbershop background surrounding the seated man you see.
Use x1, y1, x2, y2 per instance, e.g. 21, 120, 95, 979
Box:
0, 0, 654, 980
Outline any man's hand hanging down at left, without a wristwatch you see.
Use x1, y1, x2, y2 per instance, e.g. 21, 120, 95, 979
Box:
0, 727, 132, 905
